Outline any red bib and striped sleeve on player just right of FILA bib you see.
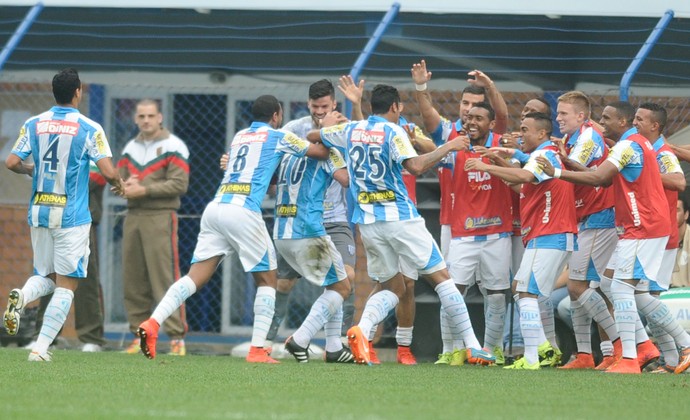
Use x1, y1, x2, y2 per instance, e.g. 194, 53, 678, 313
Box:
520, 141, 577, 245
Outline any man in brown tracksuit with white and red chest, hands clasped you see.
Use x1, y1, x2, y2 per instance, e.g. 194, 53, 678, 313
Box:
118, 99, 189, 356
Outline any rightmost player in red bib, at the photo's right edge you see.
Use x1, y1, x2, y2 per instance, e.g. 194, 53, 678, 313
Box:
633, 102, 685, 373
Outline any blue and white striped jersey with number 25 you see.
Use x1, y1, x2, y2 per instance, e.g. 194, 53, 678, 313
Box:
321, 115, 419, 224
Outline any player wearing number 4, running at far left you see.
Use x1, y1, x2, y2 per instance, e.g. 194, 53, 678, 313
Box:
3, 68, 125, 362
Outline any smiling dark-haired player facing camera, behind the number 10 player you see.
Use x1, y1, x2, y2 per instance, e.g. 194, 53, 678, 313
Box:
267, 76, 364, 341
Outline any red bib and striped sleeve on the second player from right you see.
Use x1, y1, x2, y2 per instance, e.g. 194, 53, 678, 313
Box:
608, 129, 675, 239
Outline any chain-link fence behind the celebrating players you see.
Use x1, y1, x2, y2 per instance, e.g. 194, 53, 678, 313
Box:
0, 74, 690, 344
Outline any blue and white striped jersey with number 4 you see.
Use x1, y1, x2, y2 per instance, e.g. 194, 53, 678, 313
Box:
12, 106, 112, 228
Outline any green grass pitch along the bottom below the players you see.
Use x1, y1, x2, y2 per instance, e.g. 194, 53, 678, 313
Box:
0, 348, 690, 420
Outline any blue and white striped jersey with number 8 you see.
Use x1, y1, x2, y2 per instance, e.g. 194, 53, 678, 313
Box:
213, 121, 310, 213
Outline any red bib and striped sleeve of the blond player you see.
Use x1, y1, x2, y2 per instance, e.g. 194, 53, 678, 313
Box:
564, 121, 614, 221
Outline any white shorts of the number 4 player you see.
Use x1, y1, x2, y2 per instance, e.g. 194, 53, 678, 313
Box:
31, 223, 91, 278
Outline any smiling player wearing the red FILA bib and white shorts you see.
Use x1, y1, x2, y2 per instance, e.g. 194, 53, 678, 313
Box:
448, 102, 513, 365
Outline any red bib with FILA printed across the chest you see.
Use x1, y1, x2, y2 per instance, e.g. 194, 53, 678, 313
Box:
450, 132, 513, 238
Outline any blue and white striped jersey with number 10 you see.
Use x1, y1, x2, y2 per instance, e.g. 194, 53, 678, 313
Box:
273, 149, 345, 239
